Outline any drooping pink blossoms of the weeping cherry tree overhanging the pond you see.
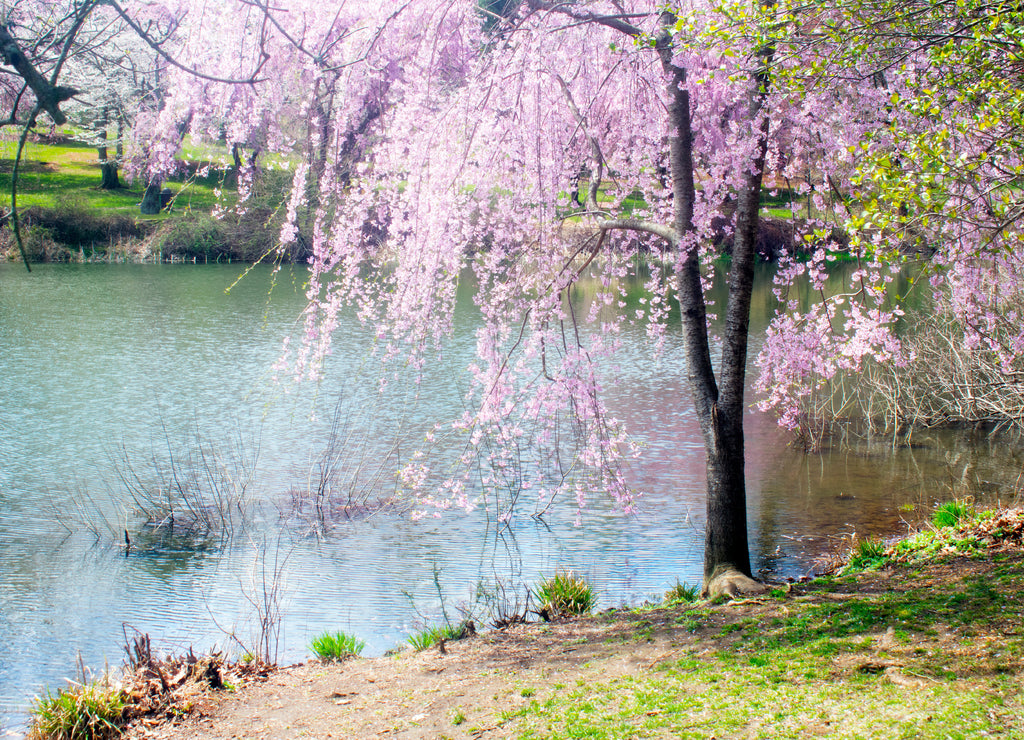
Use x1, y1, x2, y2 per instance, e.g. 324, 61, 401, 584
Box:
123, 0, 1024, 517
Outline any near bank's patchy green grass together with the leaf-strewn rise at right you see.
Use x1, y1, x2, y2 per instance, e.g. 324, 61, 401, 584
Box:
501, 507, 1024, 740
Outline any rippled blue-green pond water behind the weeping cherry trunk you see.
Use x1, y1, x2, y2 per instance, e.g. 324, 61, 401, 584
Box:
0, 265, 1021, 733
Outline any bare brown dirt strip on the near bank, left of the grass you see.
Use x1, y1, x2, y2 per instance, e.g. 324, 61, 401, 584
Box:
125, 615, 693, 739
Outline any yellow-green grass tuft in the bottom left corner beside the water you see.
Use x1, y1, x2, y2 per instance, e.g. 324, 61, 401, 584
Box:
30, 682, 125, 740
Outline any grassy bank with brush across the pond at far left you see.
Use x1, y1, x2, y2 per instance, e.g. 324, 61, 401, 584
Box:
0, 140, 304, 262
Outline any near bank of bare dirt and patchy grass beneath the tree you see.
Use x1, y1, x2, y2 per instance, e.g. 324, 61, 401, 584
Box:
25, 510, 1024, 740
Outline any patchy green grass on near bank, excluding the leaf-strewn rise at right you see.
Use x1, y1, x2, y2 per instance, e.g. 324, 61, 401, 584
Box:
502, 564, 1024, 738
